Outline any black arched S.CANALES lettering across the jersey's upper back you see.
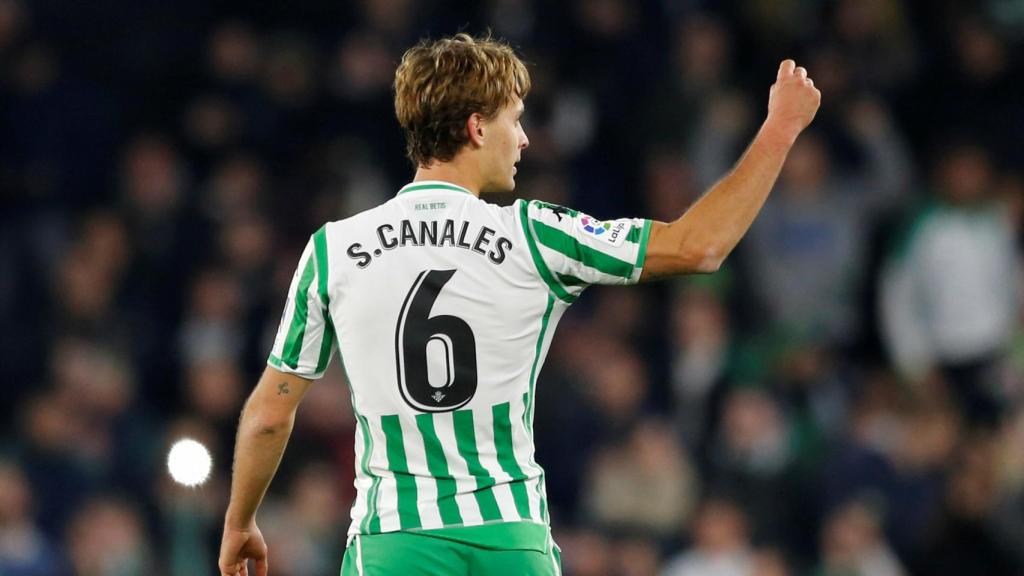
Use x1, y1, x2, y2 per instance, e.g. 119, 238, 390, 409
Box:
345, 218, 512, 269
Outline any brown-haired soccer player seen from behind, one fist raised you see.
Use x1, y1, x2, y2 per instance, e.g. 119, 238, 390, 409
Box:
219, 34, 820, 576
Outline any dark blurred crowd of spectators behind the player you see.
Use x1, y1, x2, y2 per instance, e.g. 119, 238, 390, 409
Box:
0, 0, 1024, 576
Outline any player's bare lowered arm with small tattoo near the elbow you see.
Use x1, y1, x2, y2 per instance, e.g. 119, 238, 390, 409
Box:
219, 366, 312, 575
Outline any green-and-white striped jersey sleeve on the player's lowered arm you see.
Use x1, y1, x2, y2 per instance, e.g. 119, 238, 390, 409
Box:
267, 229, 337, 380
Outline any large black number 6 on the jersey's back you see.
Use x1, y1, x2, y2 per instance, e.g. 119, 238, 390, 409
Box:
394, 270, 477, 412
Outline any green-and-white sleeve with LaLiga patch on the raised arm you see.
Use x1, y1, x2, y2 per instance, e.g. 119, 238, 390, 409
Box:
517, 200, 650, 301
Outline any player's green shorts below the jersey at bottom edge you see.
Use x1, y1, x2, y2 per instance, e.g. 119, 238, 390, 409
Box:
341, 532, 562, 576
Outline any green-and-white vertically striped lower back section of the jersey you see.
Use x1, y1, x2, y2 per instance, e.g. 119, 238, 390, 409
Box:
352, 397, 547, 533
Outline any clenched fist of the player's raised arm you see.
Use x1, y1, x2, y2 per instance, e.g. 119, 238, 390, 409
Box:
765, 59, 821, 141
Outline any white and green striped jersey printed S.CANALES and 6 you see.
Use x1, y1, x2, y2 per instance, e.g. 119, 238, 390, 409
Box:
269, 181, 650, 534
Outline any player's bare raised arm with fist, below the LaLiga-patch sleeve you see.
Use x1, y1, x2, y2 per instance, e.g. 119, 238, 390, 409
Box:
641, 59, 821, 280
